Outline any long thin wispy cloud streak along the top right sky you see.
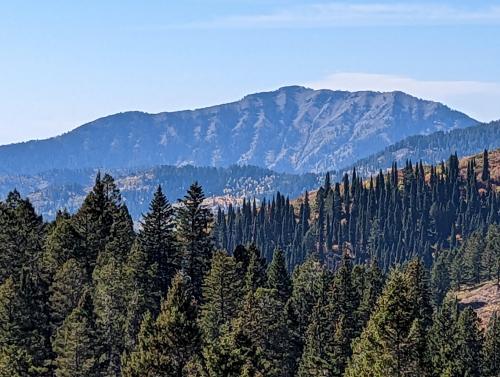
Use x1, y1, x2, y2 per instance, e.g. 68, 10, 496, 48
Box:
183, 2, 500, 28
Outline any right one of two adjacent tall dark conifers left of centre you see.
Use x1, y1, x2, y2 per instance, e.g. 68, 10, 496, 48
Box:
176, 182, 213, 299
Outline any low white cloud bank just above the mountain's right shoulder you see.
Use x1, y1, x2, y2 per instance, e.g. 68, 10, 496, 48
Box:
305, 72, 500, 121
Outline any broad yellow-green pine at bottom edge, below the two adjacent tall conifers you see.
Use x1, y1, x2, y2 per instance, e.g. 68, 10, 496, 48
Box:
123, 272, 201, 377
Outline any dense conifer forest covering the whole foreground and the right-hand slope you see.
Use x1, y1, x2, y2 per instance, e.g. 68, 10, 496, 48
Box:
0, 151, 500, 377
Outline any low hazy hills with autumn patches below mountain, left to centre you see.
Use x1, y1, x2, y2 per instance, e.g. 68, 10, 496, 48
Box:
0, 166, 323, 221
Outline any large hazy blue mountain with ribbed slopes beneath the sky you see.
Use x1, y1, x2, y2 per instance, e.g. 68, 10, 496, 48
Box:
0, 86, 477, 174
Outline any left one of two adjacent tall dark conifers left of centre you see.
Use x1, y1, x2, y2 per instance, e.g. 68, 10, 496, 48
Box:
138, 186, 181, 296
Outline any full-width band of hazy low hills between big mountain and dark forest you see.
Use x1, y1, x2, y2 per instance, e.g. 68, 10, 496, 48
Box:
0, 121, 500, 222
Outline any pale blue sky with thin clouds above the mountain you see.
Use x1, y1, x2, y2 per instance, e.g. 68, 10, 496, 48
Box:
0, 0, 500, 144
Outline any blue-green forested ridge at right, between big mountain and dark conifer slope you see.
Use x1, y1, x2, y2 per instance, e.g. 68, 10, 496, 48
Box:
345, 121, 500, 176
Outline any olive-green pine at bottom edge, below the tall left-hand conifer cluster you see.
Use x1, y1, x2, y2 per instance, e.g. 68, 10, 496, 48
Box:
53, 291, 100, 377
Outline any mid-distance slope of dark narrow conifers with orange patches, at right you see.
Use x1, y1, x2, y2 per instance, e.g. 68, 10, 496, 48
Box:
214, 149, 500, 270
